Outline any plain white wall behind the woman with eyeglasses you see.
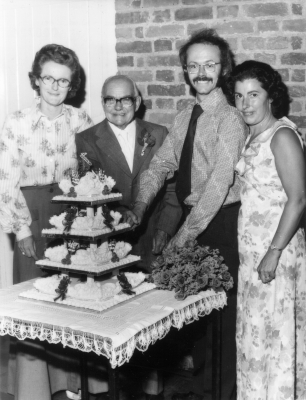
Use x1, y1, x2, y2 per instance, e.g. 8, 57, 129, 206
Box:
0, 0, 117, 287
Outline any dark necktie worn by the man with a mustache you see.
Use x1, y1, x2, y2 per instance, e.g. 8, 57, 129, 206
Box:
175, 104, 203, 203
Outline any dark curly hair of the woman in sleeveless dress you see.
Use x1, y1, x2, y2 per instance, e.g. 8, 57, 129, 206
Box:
227, 60, 290, 118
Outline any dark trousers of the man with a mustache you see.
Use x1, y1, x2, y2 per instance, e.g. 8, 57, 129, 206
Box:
185, 203, 240, 400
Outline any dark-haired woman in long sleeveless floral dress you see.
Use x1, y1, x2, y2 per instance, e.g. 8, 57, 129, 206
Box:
232, 61, 306, 400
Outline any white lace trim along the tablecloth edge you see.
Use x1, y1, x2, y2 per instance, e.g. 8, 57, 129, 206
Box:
0, 292, 226, 368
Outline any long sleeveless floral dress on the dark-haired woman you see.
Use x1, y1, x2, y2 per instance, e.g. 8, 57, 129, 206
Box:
236, 118, 306, 400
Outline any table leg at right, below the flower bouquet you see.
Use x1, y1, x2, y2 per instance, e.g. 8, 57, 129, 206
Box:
212, 310, 222, 400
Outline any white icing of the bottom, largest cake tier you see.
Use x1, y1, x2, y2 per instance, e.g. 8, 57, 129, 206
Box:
20, 272, 156, 311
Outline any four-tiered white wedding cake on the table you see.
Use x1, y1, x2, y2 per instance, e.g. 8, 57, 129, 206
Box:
20, 156, 155, 311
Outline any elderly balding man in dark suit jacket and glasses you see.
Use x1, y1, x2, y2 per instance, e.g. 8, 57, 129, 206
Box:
76, 75, 182, 271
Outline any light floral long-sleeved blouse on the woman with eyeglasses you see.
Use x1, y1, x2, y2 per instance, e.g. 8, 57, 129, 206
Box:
0, 98, 93, 240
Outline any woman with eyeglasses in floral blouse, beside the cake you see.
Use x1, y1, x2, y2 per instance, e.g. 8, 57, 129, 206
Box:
0, 44, 93, 400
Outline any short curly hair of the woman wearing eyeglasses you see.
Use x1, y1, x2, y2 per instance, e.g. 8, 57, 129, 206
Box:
29, 44, 81, 98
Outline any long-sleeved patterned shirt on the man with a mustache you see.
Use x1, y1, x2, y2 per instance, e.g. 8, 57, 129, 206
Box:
137, 88, 248, 246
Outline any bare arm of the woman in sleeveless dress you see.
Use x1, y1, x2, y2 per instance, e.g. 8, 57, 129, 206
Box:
257, 127, 306, 283
